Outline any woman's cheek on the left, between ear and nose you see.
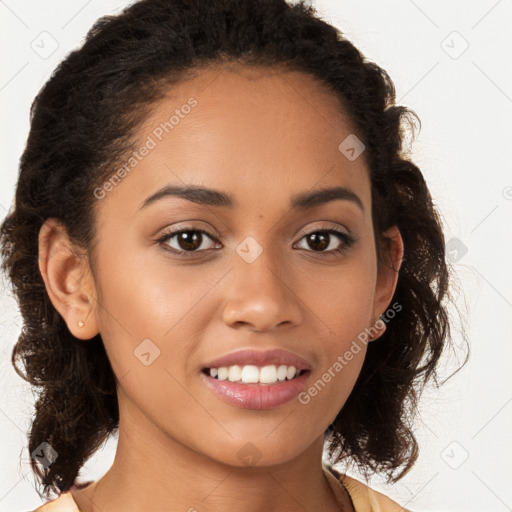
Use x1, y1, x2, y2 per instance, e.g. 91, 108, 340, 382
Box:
92, 240, 230, 403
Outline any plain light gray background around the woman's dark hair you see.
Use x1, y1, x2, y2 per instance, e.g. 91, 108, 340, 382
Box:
0, 0, 512, 512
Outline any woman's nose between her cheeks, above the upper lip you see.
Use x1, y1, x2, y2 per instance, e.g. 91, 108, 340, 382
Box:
223, 251, 302, 331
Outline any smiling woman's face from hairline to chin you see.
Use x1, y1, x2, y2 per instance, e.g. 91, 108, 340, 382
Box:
52, 63, 402, 465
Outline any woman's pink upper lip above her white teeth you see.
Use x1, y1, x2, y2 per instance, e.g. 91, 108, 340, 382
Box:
204, 349, 311, 370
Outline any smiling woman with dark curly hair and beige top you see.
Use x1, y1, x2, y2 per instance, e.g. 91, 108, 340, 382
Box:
1, 0, 456, 512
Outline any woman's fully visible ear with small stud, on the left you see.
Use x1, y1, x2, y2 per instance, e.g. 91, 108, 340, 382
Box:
38, 218, 99, 340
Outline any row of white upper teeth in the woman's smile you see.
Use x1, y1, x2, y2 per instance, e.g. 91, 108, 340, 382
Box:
209, 364, 301, 384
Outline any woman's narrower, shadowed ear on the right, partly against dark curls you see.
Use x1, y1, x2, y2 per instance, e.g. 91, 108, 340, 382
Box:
373, 226, 404, 326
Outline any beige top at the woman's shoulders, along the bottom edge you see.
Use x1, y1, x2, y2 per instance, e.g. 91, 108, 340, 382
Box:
33, 465, 410, 512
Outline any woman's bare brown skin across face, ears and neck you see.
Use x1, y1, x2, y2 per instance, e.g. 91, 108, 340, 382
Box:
39, 66, 403, 512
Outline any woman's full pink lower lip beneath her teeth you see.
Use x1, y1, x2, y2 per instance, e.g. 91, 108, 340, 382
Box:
201, 371, 311, 409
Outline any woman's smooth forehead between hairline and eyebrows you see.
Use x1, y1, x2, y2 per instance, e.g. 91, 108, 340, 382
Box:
98, 65, 371, 214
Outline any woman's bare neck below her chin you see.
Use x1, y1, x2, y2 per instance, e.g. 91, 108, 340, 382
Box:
73, 394, 349, 512
